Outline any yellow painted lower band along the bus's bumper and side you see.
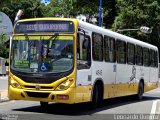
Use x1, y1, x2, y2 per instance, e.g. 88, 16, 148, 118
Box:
8, 83, 158, 104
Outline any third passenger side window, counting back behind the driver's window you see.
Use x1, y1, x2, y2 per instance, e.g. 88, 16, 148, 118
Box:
116, 40, 126, 63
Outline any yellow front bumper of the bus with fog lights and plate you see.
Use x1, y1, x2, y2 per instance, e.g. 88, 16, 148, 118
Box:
8, 85, 75, 104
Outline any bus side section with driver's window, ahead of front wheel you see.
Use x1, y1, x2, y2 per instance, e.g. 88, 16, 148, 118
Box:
75, 34, 91, 102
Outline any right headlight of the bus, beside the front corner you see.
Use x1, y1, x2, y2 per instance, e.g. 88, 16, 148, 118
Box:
56, 78, 74, 90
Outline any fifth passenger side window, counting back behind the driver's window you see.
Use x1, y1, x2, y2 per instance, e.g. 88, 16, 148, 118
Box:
136, 46, 143, 66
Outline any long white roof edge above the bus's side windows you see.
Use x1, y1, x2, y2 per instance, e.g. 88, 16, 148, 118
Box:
78, 21, 158, 50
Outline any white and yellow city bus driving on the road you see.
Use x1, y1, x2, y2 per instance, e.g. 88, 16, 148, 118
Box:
8, 18, 159, 107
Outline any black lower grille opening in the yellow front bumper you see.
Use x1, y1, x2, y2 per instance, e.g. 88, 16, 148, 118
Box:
26, 92, 50, 98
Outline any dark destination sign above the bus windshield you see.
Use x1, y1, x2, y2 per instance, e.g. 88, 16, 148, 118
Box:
14, 20, 74, 34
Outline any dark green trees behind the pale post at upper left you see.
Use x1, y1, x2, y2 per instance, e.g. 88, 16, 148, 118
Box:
0, 0, 43, 22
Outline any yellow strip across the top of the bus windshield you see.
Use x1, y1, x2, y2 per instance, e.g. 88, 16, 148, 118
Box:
13, 36, 73, 40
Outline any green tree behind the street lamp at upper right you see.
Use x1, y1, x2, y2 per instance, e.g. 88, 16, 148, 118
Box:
113, 0, 160, 45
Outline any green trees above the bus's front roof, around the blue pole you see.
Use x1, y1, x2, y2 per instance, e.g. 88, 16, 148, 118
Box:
44, 0, 116, 27
